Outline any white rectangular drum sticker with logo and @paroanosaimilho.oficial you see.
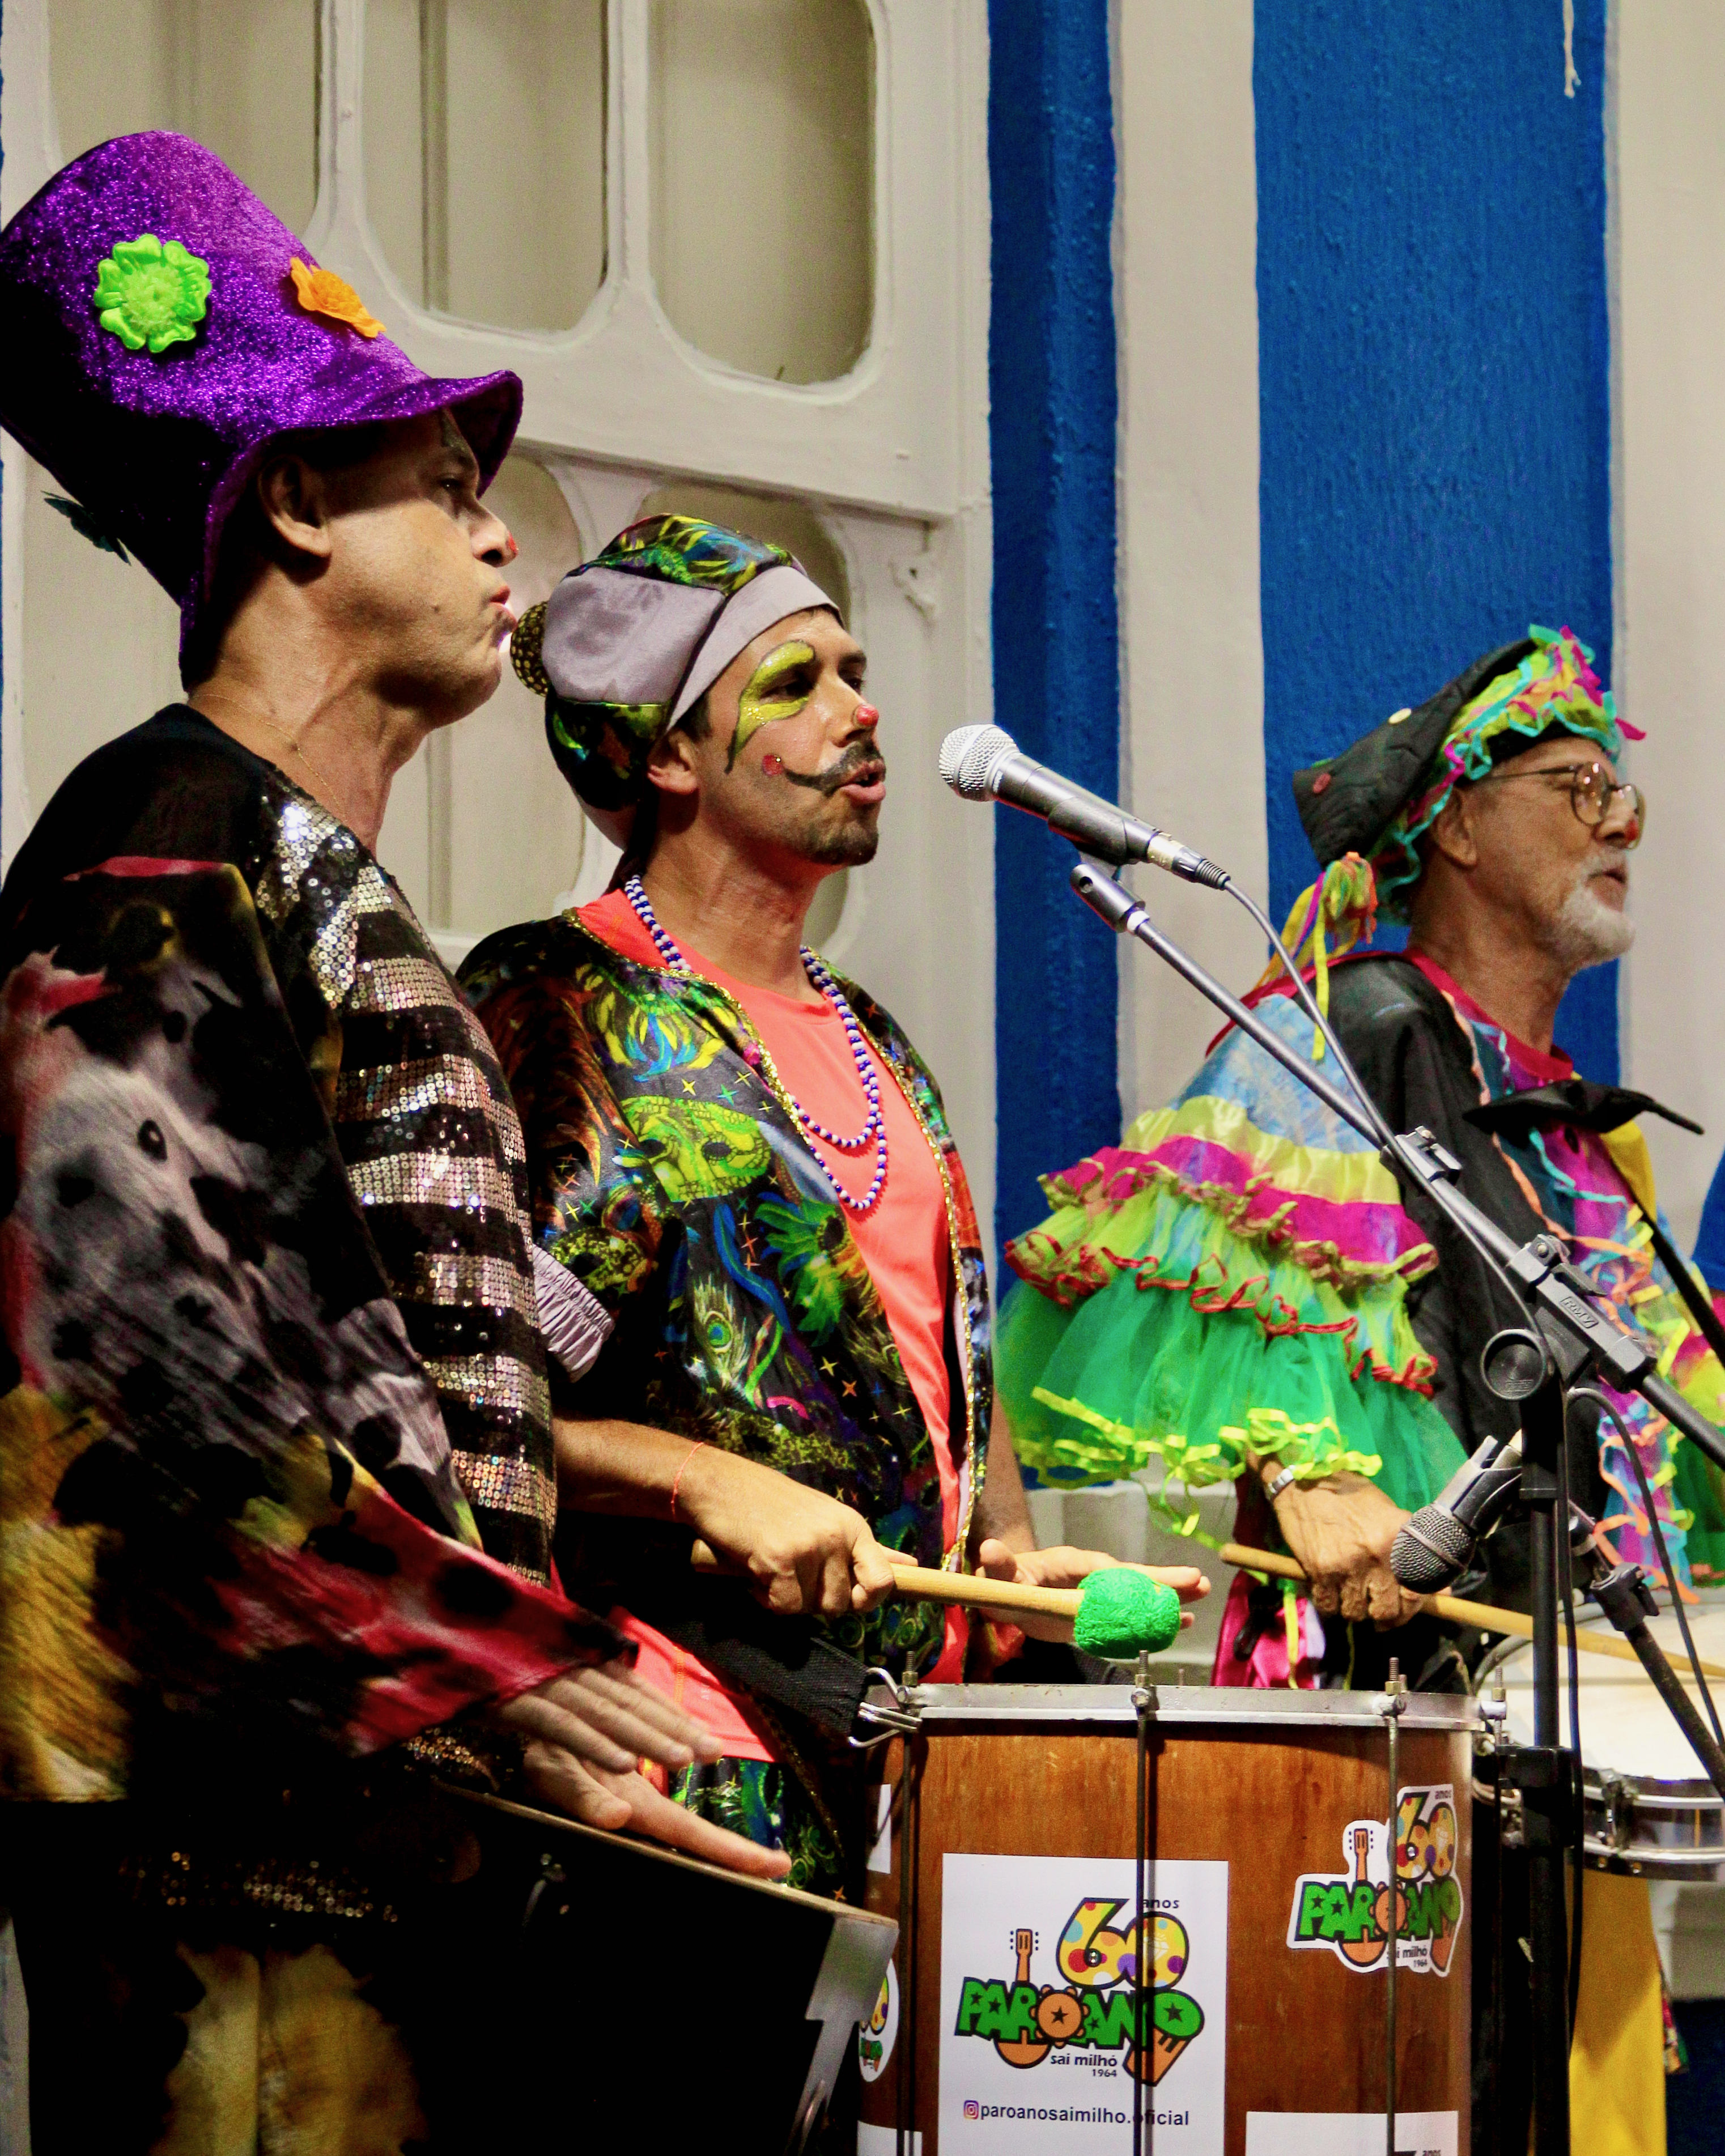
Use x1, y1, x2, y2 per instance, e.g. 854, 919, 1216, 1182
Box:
940, 1856, 1227, 2156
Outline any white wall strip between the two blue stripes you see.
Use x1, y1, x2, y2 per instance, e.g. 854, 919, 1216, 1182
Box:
1115, 0, 1268, 1121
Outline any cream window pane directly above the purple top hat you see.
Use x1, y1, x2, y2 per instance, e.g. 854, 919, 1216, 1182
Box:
48, 0, 319, 233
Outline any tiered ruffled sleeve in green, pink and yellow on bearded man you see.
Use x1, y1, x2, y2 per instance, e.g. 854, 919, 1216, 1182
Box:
996, 998, 1462, 1533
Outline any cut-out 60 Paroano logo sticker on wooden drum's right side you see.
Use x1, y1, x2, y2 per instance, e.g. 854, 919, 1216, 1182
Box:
1288, 1781, 1462, 1977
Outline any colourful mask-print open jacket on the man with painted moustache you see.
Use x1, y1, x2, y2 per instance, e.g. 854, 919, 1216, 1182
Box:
461, 914, 992, 1664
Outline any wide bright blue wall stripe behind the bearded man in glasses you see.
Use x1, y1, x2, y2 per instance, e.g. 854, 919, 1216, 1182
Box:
1253, 0, 1632, 1080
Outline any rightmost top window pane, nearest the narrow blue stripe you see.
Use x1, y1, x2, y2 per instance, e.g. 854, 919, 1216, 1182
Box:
651, 0, 876, 381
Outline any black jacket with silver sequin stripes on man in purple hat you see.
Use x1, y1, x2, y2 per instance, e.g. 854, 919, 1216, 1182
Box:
0, 707, 614, 1800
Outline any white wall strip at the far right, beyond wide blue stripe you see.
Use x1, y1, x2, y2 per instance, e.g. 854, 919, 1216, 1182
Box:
1613, 0, 1725, 1244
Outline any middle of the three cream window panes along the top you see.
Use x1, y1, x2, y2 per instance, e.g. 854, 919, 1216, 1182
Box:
362, 0, 606, 330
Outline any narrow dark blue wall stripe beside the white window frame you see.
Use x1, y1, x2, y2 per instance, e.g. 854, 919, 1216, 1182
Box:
988, 0, 1119, 1242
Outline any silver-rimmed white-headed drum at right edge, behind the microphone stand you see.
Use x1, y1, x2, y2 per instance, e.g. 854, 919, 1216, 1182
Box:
1479, 1589, 1725, 1885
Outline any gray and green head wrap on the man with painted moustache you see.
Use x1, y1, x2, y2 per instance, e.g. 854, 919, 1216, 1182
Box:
509, 517, 839, 845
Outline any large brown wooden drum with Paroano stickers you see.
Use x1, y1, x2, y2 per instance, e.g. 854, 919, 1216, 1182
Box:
858, 1684, 1477, 2156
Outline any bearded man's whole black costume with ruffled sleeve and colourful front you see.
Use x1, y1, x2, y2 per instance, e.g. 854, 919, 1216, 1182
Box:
1001, 955, 1725, 1602
